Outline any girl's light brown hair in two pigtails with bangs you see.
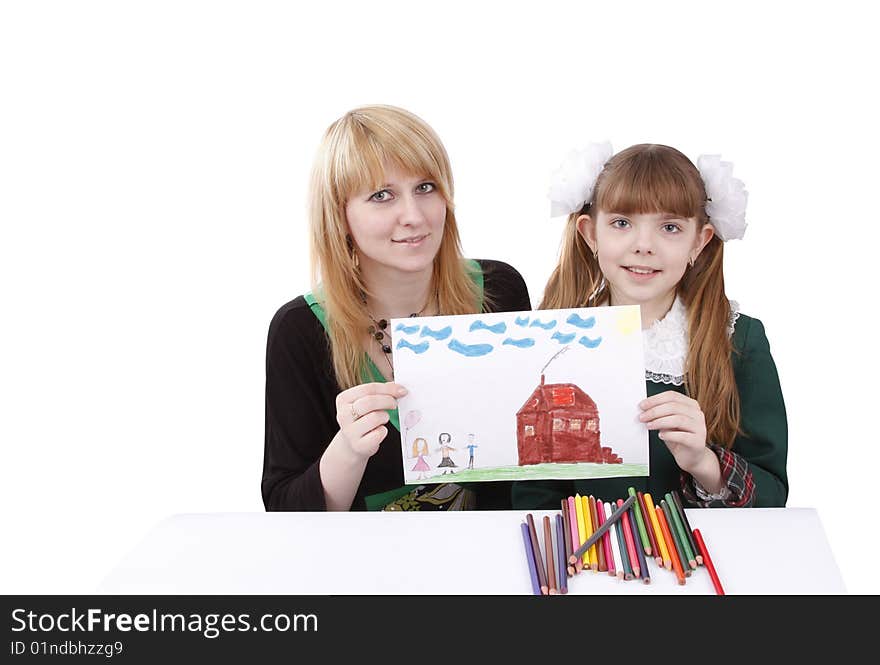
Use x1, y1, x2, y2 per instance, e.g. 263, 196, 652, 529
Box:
538, 144, 741, 448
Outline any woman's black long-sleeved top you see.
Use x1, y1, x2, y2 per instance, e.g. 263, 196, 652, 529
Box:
262, 260, 531, 510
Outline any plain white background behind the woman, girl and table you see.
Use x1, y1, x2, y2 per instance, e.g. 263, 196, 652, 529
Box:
0, 0, 880, 593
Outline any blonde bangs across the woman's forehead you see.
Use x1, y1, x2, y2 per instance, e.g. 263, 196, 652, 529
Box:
328, 114, 452, 204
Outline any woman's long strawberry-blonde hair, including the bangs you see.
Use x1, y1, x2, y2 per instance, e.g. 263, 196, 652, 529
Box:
309, 106, 480, 390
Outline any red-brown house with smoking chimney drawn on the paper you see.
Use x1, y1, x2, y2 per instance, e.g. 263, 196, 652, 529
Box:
516, 374, 623, 466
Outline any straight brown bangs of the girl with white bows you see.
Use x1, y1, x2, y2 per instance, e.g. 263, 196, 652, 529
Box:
595, 145, 706, 219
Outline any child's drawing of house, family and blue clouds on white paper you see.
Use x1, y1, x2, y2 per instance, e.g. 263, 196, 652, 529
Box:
392, 306, 649, 483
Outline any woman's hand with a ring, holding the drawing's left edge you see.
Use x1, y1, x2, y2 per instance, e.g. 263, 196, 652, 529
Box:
336, 382, 407, 459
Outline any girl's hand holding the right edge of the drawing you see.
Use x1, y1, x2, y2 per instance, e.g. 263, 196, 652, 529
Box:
639, 390, 712, 474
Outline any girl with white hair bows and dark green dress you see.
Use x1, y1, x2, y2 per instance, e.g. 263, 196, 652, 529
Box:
513, 144, 788, 509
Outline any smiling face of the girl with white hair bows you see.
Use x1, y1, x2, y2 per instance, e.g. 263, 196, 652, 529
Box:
578, 210, 714, 308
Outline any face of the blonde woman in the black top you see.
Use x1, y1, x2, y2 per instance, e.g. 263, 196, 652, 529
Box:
345, 168, 446, 276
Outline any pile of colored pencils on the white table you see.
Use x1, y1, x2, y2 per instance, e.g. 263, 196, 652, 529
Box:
521, 487, 724, 595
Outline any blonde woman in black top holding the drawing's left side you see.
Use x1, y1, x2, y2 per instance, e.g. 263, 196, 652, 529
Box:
262, 106, 531, 510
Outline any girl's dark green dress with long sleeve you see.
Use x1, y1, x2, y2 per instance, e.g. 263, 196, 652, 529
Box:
511, 306, 788, 510
